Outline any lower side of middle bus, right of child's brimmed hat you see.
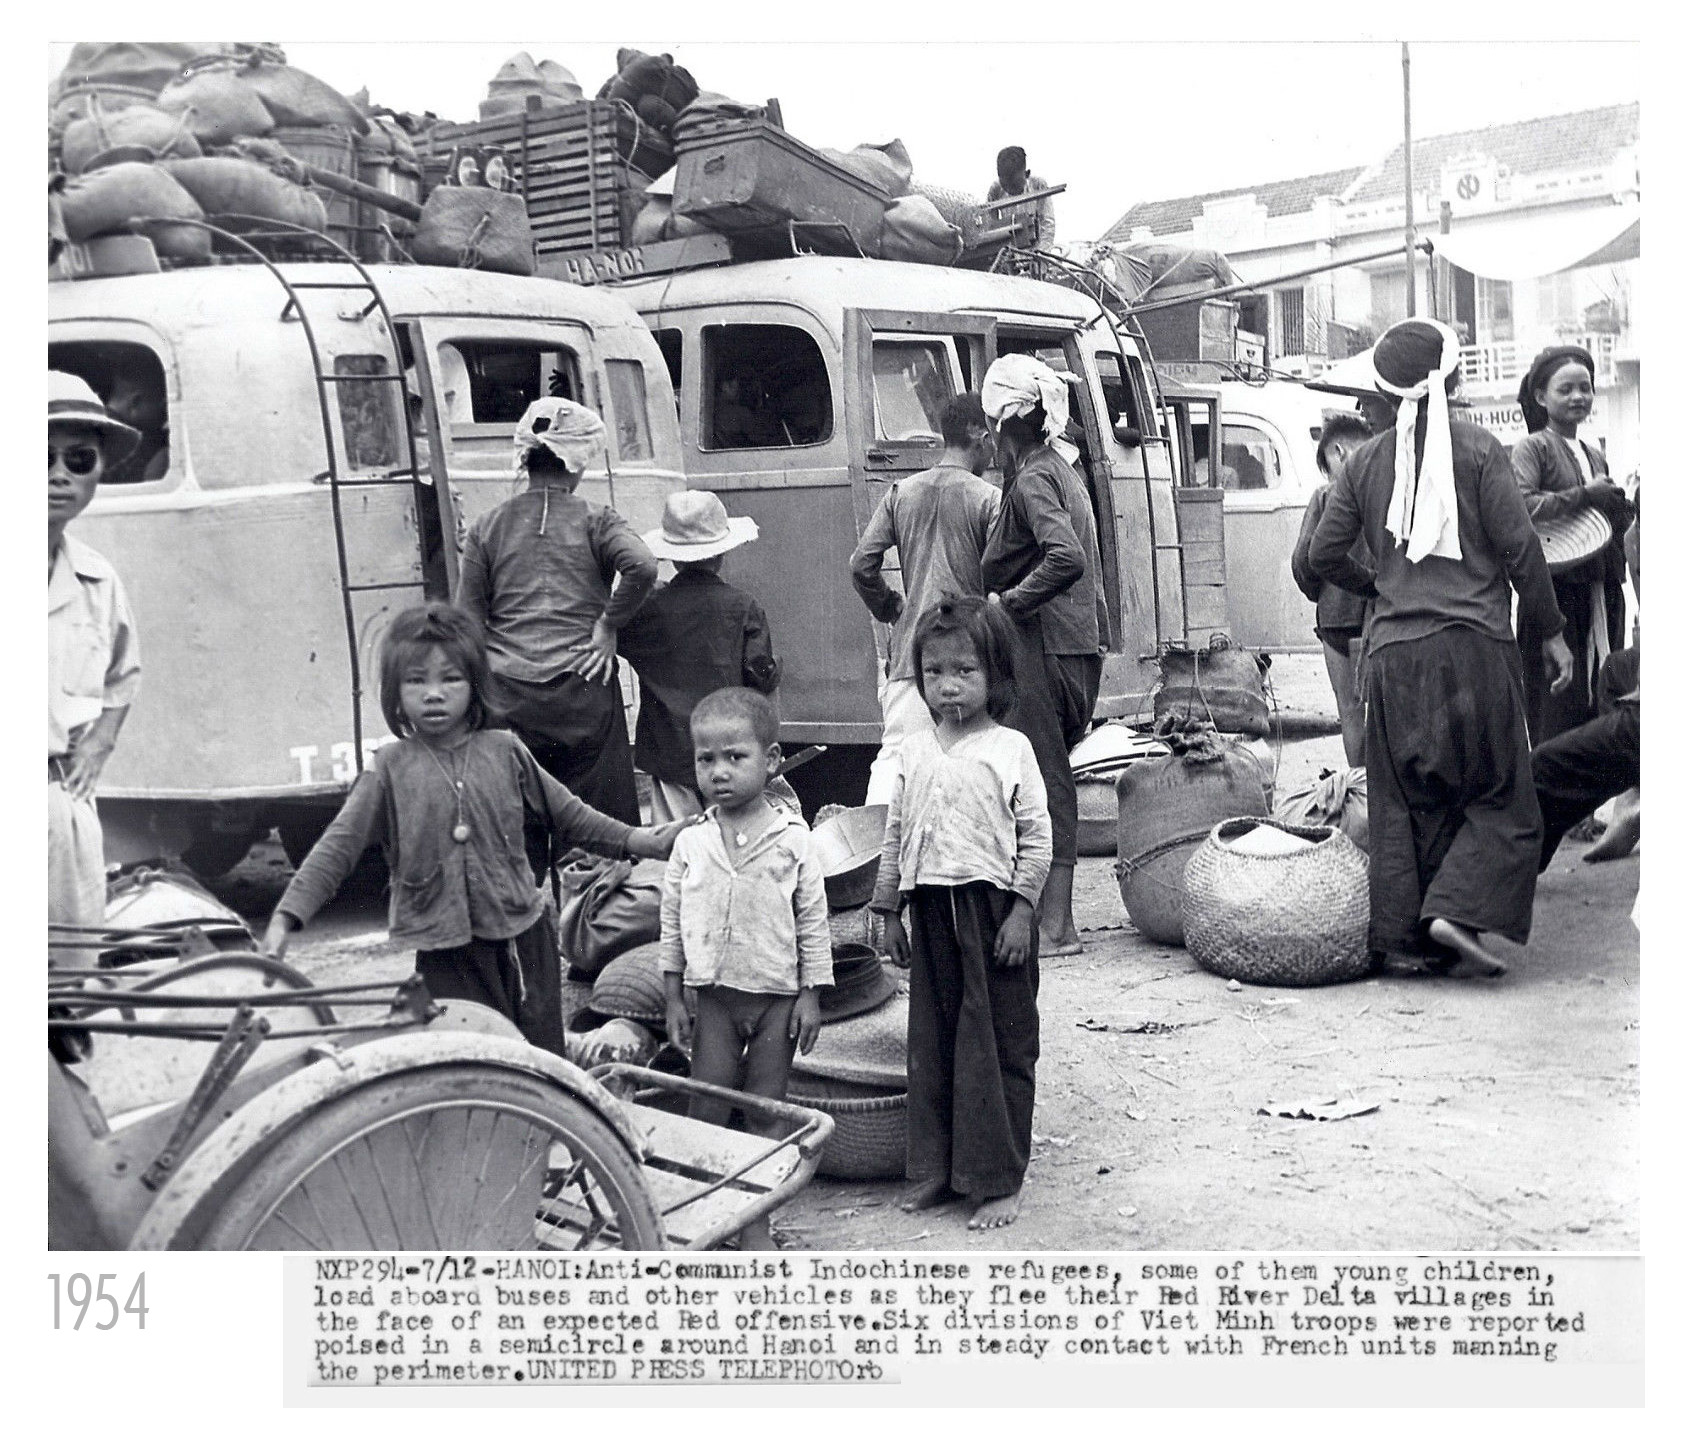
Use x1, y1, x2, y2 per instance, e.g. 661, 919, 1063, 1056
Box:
706, 481, 879, 743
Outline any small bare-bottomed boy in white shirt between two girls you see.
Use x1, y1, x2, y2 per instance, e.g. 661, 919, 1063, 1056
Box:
662, 689, 832, 1248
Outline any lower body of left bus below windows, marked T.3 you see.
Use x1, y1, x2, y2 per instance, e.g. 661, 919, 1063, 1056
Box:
78, 486, 420, 799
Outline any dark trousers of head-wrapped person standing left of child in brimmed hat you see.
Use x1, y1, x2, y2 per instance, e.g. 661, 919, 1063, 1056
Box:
495, 674, 640, 827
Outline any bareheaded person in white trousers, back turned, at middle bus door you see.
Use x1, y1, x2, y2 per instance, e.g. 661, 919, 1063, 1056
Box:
849, 393, 1001, 804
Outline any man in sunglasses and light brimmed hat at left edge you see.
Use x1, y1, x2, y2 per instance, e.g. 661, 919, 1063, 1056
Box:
47, 370, 140, 927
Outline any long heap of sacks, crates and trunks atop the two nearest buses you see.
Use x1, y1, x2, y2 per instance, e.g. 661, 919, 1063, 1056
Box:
49, 42, 1006, 275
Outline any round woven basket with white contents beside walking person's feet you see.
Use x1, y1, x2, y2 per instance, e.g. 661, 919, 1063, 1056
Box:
1183, 817, 1371, 988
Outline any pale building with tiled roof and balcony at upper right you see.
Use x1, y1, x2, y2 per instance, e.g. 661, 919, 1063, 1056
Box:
1104, 105, 1641, 476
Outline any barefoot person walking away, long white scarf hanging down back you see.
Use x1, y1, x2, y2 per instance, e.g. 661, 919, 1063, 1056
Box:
1308, 319, 1572, 976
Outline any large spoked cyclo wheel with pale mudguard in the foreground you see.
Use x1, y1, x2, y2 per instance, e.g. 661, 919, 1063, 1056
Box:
188, 1064, 662, 1251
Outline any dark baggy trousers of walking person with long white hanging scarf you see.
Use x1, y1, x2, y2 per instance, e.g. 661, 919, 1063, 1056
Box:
1366, 625, 1541, 952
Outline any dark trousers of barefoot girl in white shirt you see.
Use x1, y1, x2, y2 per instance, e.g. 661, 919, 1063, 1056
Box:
903, 883, 1038, 1201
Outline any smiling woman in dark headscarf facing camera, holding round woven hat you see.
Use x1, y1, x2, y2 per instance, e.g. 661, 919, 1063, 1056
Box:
1512, 344, 1631, 743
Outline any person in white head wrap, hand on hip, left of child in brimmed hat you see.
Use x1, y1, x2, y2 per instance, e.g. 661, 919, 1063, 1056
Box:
457, 399, 657, 826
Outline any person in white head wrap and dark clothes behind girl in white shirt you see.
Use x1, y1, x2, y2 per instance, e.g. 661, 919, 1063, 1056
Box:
979, 355, 1109, 957
